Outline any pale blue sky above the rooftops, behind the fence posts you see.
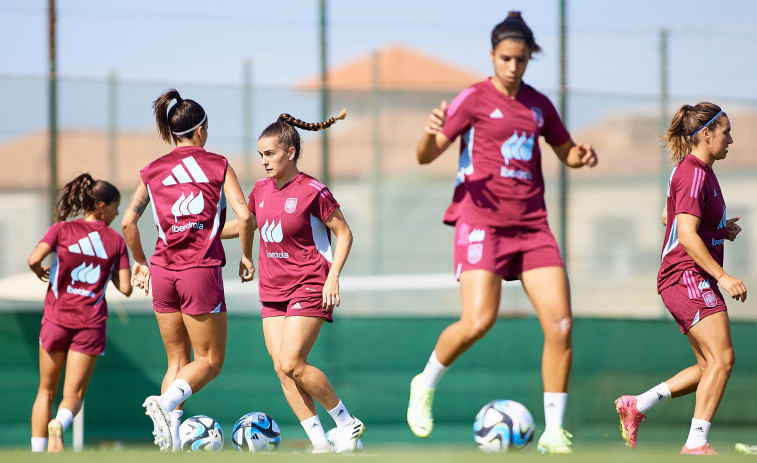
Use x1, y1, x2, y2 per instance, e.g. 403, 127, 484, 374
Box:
0, 0, 757, 100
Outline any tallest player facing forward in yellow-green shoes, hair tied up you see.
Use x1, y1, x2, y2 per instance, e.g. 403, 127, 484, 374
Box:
407, 11, 597, 453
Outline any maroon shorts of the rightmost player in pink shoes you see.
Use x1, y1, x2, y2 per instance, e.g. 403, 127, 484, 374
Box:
660, 270, 726, 334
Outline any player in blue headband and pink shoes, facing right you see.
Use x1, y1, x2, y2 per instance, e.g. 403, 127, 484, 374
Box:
615, 103, 746, 455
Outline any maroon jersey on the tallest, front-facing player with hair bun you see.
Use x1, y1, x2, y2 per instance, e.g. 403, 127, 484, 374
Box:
442, 79, 570, 227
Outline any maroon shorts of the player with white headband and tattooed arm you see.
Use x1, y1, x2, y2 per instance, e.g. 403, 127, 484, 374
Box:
150, 265, 226, 315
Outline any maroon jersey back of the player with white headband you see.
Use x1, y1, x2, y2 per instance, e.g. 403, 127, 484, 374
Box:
140, 146, 229, 270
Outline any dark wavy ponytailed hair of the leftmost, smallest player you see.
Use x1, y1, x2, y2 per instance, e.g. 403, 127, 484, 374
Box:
55, 173, 121, 221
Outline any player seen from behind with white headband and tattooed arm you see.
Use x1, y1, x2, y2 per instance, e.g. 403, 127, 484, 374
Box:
121, 89, 254, 451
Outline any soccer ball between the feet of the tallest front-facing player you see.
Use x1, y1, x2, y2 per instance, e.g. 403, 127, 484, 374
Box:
473, 400, 534, 452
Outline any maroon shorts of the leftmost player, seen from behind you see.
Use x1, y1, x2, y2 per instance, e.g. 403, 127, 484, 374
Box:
39, 318, 106, 355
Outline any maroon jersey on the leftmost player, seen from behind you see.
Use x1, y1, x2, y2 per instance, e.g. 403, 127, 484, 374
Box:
41, 219, 129, 328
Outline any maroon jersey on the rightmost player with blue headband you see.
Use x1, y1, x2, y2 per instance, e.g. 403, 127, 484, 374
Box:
657, 155, 726, 292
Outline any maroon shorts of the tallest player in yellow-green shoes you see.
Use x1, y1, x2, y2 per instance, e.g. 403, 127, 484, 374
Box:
455, 221, 564, 281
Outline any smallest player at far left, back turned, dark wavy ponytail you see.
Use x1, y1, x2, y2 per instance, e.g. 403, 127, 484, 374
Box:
29, 174, 132, 452
